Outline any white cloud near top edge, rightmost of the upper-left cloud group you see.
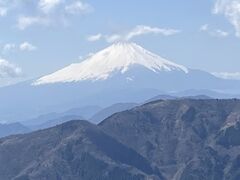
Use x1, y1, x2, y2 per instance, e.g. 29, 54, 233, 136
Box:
65, 1, 93, 14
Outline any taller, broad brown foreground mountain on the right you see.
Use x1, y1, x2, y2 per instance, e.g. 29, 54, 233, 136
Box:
99, 99, 240, 180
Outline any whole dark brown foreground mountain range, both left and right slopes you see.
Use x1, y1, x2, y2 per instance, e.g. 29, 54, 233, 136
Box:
0, 99, 240, 180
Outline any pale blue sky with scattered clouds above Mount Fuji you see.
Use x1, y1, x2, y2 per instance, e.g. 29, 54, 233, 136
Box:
0, 0, 240, 86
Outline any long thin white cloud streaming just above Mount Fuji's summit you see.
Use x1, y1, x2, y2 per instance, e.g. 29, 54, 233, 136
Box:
88, 25, 181, 43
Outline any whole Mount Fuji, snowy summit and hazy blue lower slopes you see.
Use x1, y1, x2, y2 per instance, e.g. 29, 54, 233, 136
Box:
0, 42, 240, 122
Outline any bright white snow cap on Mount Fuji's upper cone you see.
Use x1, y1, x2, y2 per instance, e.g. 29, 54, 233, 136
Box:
34, 42, 188, 85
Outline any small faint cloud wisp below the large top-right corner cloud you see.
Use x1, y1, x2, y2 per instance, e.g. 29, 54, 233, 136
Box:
200, 24, 229, 38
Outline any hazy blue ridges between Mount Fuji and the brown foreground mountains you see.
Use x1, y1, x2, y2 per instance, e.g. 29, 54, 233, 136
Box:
0, 91, 232, 137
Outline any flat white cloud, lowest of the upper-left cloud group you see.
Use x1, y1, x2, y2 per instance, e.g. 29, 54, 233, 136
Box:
17, 16, 49, 30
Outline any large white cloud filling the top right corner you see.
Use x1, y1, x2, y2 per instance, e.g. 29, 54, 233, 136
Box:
213, 0, 240, 37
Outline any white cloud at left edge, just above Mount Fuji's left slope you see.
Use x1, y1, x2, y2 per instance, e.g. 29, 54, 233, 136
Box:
0, 58, 22, 78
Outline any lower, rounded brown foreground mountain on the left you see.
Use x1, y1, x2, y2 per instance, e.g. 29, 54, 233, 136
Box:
0, 121, 162, 180
